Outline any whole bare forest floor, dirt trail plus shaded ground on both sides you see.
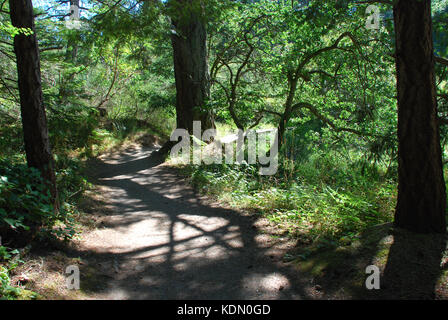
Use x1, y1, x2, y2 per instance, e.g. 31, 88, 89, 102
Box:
9, 144, 448, 300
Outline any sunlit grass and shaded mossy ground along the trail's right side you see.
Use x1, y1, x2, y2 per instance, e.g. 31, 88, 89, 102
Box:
172, 136, 448, 299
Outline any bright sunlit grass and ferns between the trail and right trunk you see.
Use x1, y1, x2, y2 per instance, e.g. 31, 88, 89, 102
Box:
180, 146, 396, 242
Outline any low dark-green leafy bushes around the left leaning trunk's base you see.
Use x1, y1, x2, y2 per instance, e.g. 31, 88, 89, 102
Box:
0, 157, 89, 239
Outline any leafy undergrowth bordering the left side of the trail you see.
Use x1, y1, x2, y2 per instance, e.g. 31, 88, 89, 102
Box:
0, 112, 170, 299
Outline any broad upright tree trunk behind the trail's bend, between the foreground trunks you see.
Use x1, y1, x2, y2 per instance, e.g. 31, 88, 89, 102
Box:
171, 0, 215, 133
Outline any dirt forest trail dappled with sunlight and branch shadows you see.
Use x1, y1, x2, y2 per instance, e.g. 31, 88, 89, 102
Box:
75, 146, 318, 299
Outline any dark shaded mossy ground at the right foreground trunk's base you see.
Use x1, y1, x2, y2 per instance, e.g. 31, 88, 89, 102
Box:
291, 223, 448, 300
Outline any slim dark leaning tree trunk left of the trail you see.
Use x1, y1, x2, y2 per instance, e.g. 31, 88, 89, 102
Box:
9, 0, 58, 210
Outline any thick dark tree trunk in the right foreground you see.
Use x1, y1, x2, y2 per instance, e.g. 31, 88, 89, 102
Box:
394, 0, 446, 233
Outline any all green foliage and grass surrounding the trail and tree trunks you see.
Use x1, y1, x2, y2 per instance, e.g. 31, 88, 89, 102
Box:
0, 0, 448, 292
